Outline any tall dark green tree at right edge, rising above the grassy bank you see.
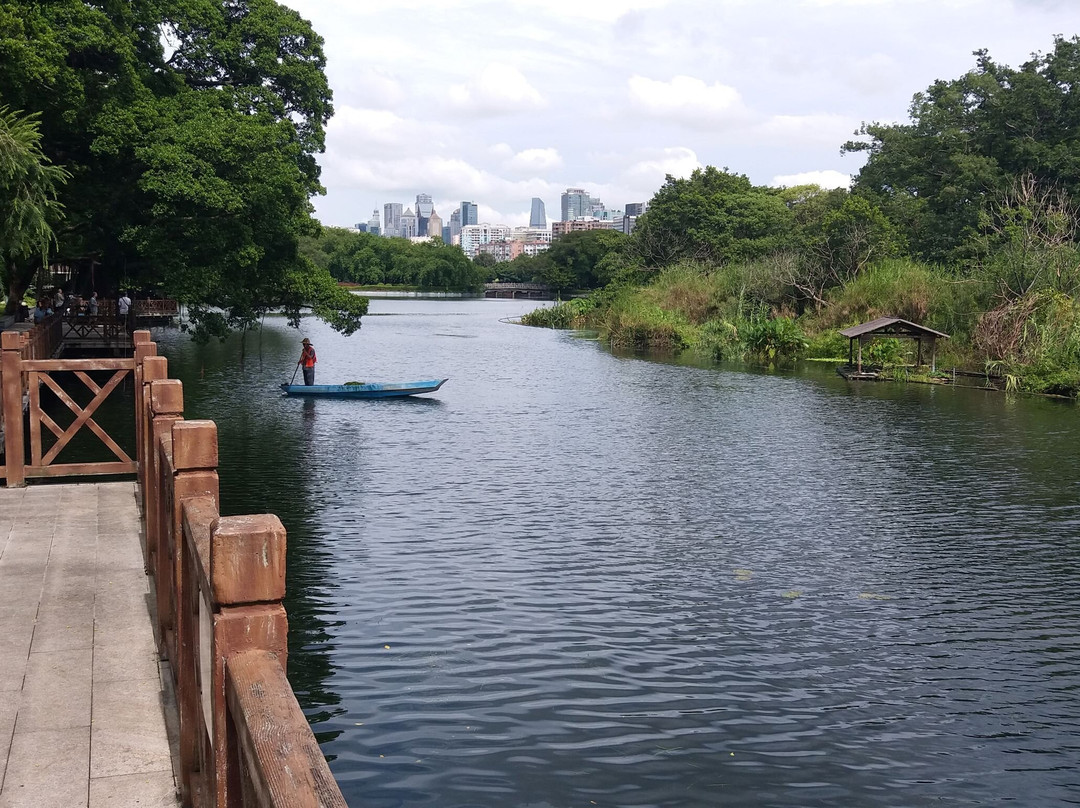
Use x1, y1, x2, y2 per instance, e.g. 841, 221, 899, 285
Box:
843, 37, 1080, 260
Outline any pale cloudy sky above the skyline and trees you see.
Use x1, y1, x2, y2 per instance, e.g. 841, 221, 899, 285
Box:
280, 0, 1080, 227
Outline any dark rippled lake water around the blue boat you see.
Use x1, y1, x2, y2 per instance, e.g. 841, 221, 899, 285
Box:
156, 299, 1080, 808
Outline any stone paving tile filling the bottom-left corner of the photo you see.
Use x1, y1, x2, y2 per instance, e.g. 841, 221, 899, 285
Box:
0, 722, 90, 808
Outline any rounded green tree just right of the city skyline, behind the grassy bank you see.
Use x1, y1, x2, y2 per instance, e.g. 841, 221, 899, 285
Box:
632, 165, 792, 267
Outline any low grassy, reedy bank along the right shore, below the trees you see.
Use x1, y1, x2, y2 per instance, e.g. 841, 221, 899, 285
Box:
522, 257, 1080, 398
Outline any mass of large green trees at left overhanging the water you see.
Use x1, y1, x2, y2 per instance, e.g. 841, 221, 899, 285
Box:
0, 0, 367, 338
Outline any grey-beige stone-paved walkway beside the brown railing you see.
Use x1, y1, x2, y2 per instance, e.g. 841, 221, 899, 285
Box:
0, 483, 177, 808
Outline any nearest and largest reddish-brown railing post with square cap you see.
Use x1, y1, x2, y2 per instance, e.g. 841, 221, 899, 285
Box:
203, 514, 287, 806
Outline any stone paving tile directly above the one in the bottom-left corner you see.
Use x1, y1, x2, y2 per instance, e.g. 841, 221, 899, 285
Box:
18, 648, 93, 730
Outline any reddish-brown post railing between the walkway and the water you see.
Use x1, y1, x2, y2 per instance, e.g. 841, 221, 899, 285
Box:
134, 332, 346, 808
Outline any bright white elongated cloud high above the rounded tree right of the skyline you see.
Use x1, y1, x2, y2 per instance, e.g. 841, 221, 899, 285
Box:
627, 76, 747, 125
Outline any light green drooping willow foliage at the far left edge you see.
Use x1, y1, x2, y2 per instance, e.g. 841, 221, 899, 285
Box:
0, 107, 69, 312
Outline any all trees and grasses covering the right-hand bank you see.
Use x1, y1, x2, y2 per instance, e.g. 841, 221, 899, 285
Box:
525, 38, 1080, 396
